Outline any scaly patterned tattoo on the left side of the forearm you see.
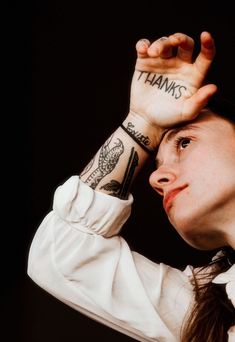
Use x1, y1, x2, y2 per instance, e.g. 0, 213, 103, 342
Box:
85, 136, 124, 189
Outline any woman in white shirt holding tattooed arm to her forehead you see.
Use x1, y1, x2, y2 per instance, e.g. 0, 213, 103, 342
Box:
28, 32, 235, 342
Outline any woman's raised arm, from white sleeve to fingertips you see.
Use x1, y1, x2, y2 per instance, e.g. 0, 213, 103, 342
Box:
28, 33, 216, 342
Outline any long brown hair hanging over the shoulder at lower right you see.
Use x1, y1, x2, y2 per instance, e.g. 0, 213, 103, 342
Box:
181, 249, 235, 342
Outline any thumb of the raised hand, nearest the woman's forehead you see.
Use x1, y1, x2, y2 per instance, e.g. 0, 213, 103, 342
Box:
182, 84, 217, 121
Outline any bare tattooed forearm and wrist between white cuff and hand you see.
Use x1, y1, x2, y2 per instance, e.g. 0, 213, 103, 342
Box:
80, 114, 161, 199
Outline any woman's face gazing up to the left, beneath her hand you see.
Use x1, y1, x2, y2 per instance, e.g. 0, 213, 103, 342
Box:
150, 110, 235, 249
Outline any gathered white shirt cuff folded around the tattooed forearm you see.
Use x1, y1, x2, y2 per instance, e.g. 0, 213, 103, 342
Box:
53, 176, 133, 237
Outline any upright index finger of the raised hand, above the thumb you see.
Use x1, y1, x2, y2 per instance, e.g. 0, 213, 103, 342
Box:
195, 32, 215, 74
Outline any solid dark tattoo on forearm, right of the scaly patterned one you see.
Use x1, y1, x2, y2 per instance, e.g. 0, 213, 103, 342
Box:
100, 147, 139, 199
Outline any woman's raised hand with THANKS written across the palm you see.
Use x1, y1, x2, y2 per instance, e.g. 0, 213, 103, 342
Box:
130, 32, 217, 128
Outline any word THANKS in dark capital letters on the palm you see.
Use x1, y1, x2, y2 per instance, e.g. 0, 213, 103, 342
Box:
138, 71, 187, 99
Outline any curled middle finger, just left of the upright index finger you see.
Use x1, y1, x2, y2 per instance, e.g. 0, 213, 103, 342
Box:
169, 33, 194, 63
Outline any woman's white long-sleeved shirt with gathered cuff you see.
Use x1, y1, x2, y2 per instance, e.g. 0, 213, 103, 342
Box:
28, 176, 235, 342
